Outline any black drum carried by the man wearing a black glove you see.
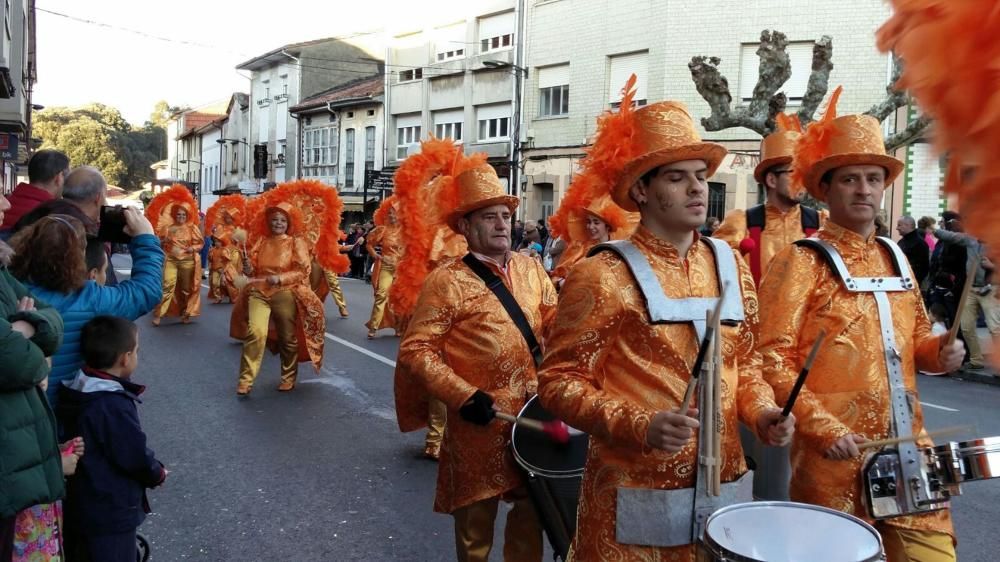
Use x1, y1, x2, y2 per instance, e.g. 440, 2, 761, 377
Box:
510, 396, 588, 478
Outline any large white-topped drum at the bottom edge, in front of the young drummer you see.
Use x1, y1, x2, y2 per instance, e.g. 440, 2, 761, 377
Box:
698, 502, 885, 562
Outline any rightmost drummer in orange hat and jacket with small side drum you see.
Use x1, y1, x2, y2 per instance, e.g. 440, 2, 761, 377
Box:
759, 103, 964, 562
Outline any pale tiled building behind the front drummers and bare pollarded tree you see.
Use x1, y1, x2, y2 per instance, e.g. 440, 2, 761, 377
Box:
521, 0, 940, 224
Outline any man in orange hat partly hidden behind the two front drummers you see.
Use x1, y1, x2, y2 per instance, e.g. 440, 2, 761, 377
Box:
712, 115, 827, 501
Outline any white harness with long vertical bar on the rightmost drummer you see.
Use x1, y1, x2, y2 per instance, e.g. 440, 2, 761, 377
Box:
795, 237, 930, 512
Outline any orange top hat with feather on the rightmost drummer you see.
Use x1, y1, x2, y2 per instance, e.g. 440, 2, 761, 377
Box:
792, 86, 903, 201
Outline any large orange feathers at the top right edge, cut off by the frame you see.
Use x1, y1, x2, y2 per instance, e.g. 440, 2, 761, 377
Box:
876, 0, 1000, 264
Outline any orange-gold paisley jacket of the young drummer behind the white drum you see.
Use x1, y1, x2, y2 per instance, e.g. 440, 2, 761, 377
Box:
538, 226, 775, 561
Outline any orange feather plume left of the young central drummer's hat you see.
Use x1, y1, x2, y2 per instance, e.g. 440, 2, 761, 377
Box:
549, 74, 639, 237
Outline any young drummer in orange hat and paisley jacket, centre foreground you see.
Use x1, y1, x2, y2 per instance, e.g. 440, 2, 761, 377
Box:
538, 97, 794, 562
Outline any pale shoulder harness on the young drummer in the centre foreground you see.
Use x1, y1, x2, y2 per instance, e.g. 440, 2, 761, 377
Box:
587, 236, 744, 336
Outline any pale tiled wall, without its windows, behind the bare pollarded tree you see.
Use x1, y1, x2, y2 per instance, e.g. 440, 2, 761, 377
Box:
522, 0, 891, 221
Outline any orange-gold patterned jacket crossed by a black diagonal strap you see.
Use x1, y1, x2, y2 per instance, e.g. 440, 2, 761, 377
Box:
397, 253, 556, 513
